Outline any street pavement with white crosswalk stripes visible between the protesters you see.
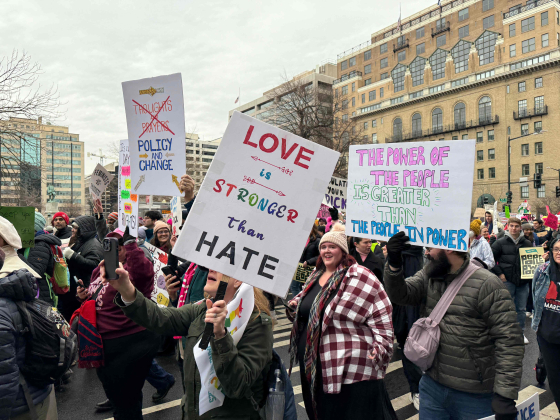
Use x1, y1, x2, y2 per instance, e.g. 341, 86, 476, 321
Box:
57, 307, 558, 420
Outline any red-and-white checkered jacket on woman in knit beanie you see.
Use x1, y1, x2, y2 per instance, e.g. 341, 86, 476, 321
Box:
294, 264, 394, 394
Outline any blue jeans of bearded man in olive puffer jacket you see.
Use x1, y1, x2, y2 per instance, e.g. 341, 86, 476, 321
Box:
420, 375, 494, 420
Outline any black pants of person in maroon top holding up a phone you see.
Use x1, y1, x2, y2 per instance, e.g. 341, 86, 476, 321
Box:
97, 331, 161, 420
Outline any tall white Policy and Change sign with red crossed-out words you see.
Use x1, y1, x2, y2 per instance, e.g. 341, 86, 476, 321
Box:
122, 73, 186, 195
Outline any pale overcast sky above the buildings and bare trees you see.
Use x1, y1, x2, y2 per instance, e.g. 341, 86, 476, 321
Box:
0, 0, 436, 175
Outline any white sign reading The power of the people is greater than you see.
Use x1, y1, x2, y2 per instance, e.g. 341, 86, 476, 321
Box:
346, 140, 475, 251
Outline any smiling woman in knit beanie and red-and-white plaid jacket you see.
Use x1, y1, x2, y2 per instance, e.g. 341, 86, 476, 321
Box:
288, 223, 397, 420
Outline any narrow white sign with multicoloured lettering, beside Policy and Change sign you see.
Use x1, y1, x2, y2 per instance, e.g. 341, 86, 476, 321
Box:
118, 140, 138, 237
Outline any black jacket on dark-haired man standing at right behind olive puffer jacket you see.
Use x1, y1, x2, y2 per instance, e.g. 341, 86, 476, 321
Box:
491, 232, 533, 286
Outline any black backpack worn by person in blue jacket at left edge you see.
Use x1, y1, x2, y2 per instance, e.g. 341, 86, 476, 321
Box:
15, 299, 78, 388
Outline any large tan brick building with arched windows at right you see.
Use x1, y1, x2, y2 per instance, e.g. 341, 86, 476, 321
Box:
333, 0, 560, 213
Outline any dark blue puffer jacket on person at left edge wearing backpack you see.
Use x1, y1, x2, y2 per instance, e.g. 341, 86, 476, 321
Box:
0, 270, 52, 420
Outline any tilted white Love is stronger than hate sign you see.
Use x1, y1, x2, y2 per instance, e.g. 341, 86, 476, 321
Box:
173, 112, 339, 296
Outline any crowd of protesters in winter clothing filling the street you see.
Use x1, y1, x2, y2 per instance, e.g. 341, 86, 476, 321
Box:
0, 175, 560, 420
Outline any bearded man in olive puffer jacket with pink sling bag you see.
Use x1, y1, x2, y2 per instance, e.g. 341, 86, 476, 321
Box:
383, 232, 525, 420
